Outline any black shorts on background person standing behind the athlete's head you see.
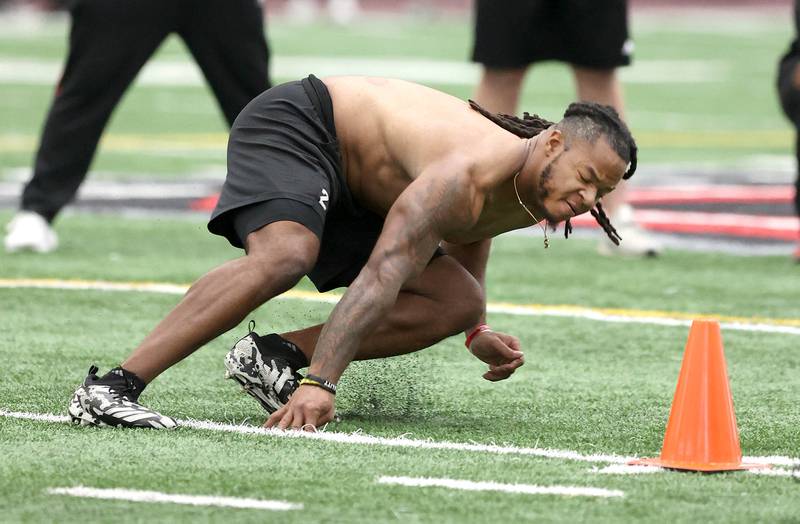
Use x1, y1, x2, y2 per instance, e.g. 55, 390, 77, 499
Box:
472, 0, 633, 69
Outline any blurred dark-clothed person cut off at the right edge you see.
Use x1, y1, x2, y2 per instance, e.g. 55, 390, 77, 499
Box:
778, 2, 800, 263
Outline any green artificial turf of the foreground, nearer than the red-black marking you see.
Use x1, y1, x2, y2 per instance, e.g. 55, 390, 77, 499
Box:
0, 211, 800, 522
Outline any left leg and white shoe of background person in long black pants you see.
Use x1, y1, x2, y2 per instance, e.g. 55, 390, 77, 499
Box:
5, 0, 175, 252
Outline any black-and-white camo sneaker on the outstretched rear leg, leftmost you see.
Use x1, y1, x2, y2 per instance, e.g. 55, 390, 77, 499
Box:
68, 366, 178, 429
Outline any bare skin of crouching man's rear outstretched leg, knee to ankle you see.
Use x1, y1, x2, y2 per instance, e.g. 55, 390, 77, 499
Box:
122, 221, 319, 382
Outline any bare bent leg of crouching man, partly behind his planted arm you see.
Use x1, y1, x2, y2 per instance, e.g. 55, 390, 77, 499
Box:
282, 256, 483, 361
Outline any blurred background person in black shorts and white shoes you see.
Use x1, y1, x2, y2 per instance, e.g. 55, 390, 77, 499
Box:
472, 0, 661, 256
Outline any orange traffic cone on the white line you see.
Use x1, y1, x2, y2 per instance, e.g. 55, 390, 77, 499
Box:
629, 320, 769, 471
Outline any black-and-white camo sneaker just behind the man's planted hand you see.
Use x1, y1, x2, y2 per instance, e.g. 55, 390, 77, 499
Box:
225, 322, 308, 413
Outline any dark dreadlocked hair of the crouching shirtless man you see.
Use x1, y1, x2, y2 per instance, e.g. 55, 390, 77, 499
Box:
469, 100, 638, 245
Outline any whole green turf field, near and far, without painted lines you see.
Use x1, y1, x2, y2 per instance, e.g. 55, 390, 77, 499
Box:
0, 9, 800, 523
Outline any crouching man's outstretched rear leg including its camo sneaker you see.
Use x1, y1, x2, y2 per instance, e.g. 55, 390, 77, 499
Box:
68, 221, 319, 428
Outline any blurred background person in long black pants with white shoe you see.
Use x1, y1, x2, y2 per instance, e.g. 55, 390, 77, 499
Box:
5, 0, 270, 253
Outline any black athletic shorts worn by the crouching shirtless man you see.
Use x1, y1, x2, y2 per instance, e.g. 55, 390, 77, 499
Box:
208, 75, 384, 291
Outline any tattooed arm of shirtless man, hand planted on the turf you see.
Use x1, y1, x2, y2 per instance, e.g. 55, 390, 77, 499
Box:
265, 166, 483, 428
